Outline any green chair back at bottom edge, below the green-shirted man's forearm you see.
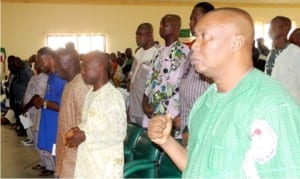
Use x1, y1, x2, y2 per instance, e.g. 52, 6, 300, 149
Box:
158, 152, 181, 178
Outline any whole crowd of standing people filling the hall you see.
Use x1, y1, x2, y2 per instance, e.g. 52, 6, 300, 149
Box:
0, 2, 300, 178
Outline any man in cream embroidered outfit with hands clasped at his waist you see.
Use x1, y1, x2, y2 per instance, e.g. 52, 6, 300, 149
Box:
65, 51, 127, 178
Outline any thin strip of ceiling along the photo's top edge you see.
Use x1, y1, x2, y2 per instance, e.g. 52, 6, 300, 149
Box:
2, 0, 300, 6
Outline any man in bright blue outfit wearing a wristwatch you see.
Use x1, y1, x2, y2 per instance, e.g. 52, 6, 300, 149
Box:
34, 47, 66, 176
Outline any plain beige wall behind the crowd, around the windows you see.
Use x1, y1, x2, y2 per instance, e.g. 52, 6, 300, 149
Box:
1, 2, 300, 59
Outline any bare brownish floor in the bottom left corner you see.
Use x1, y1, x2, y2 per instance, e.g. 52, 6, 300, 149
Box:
0, 125, 53, 178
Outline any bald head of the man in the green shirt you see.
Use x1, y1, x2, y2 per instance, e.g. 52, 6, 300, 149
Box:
191, 8, 254, 80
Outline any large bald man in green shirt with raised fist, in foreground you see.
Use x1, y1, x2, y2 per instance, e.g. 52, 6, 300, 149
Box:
148, 8, 300, 178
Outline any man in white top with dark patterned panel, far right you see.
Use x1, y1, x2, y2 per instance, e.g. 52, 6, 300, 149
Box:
265, 16, 300, 105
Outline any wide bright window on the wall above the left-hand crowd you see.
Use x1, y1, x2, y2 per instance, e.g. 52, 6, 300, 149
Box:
46, 34, 106, 54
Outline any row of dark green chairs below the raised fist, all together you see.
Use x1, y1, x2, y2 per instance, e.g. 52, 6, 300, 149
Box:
124, 123, 181, 178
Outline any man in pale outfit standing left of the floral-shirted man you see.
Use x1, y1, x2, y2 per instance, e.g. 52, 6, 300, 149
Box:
129, 23, 158, 126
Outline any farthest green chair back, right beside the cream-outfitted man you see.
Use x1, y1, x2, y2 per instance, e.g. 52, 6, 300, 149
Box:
124, 123, 144, 150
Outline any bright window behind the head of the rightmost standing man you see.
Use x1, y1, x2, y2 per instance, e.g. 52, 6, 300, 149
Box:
255, 21, 296, 49
